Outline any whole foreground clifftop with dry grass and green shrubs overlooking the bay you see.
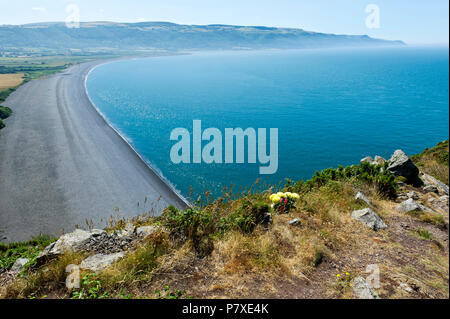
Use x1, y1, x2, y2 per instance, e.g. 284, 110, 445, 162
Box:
0, 141, 449, 298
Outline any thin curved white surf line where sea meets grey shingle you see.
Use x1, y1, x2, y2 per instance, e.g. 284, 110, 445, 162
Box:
83, 57, 192, 207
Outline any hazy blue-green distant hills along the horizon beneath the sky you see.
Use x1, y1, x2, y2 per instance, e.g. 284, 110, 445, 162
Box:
0, 22, 404, 51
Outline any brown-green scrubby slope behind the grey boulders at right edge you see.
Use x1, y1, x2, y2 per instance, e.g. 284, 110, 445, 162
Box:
411, 140, 449, 185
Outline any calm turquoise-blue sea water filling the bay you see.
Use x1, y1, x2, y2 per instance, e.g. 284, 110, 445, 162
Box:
87, 48, 449, 200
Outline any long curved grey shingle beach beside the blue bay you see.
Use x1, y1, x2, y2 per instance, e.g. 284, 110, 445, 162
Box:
0, 61, 186, 242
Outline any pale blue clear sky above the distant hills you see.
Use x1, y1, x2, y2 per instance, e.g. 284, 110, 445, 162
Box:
0, 0, 449, 45
